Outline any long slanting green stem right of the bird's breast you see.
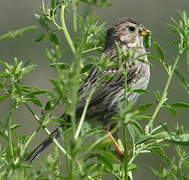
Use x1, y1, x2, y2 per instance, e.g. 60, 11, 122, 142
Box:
146, 53, 181, 132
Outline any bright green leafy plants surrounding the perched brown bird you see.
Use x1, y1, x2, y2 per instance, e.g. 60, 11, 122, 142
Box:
0, 0, 189, 180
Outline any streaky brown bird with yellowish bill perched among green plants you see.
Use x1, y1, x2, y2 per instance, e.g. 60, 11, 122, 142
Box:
26, 17, 150, 163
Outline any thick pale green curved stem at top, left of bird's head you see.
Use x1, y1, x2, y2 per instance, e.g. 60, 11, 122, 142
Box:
60, 5, 76, 54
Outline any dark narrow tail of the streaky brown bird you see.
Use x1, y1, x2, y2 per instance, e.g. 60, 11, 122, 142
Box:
25, 127, 60, 164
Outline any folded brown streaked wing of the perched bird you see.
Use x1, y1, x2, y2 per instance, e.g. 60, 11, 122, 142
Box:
77, 62, 138, 116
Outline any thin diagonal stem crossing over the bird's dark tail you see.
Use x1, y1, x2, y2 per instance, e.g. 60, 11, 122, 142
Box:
24, 103, 72, 159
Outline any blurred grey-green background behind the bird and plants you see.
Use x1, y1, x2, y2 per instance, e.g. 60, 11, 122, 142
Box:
0, 0, 189, 180
